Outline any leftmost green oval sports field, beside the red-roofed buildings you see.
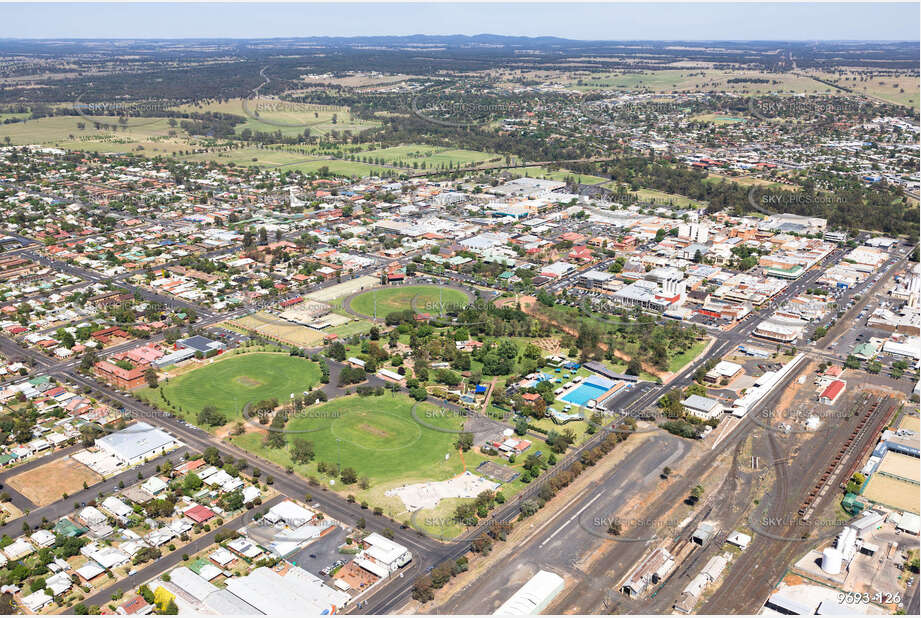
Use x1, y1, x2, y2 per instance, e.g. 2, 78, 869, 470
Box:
139, 352, 320, 422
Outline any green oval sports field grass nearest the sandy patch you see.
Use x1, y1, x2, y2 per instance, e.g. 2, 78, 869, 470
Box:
232, 394, 463, 486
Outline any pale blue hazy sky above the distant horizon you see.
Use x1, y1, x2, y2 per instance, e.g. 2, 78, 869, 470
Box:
0, 2, 921, 41
